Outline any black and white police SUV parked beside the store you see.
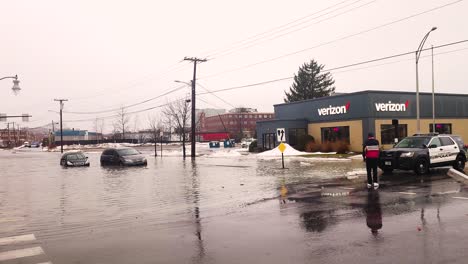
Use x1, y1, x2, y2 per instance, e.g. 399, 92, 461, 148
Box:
379, 133, 467, 174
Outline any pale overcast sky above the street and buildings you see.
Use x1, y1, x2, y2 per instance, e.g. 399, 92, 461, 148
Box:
0, 0, 468, 132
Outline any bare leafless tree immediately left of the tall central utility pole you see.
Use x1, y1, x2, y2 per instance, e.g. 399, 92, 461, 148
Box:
163, 99, 191, 158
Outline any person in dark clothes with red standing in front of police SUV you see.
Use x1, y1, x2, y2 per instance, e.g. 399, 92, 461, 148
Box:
362, 132, 380, 189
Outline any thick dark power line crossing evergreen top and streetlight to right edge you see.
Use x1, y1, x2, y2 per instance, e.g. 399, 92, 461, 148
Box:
198, 39, 468, 95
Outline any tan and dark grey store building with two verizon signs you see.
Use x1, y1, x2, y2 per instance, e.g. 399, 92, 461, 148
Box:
257, 91, 468, 152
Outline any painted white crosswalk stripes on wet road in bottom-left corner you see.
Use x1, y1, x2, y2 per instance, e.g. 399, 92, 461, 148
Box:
0, 234, 52, 264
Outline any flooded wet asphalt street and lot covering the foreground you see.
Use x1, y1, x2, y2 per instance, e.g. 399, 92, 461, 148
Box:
0, 148, 468, 264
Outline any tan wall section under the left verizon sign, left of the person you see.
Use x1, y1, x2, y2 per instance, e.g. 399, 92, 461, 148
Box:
307, 120, 364, 152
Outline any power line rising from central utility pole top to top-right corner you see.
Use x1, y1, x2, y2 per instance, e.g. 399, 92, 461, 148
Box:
199, 0, 464, 79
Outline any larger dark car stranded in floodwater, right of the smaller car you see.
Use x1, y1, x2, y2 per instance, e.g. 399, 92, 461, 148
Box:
101, 148, 148, 166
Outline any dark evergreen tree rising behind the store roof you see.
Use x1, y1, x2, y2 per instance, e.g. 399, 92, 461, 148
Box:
284, 60, 335, 103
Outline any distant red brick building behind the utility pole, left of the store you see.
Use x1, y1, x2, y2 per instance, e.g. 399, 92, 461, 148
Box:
199, 109, 274, 141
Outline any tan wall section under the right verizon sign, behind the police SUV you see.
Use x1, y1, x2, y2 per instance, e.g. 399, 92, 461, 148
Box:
375, 118, 468, 149
